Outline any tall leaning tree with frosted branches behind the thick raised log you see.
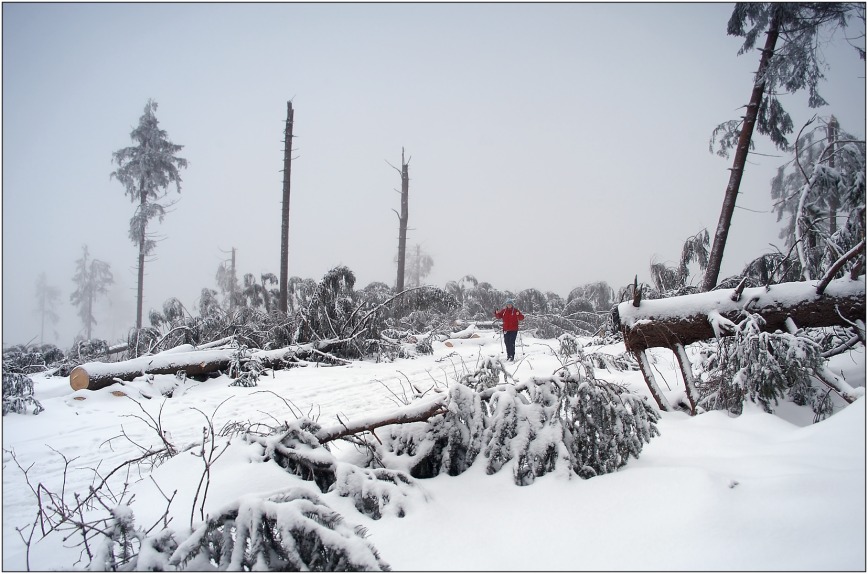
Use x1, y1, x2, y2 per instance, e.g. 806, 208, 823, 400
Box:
702, 2, 856, 291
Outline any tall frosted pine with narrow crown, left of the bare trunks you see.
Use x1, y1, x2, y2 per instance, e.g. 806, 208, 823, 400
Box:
111, 100, 187, 329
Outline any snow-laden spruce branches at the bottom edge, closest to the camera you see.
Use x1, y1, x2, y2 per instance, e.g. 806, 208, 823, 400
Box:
170, 488, 389, 572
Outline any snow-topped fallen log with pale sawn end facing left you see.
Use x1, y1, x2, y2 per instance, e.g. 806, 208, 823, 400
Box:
69, 348, 298, 391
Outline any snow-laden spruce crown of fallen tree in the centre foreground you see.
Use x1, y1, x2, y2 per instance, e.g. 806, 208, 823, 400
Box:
380, 362, 658, 485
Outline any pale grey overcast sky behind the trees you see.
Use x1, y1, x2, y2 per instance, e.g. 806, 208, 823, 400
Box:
2, 3, 865, 347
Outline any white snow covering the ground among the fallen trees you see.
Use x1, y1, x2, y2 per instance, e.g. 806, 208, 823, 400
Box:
2, 332, 866, 571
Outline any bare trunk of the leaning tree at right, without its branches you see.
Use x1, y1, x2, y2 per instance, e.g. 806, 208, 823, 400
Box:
702, 10, 780, 291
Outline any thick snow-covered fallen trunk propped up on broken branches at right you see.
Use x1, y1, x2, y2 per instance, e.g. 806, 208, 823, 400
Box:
613, 275, 865, 352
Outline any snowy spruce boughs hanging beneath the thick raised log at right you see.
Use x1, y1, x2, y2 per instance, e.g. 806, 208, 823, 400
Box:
698, 314, 828, 415
